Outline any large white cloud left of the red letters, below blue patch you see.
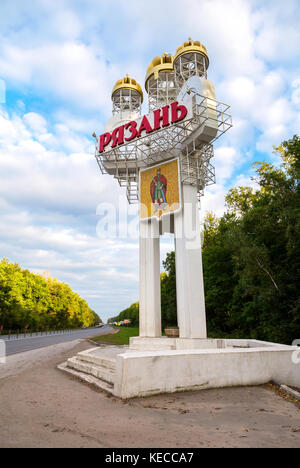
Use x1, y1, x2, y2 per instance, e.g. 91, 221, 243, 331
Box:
0, 109, 123, 213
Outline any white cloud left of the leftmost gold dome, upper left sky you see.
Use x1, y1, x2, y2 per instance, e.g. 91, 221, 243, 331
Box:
0, 41, 119, 112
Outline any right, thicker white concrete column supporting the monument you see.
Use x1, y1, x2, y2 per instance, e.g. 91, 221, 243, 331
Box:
175, 185, 207, 338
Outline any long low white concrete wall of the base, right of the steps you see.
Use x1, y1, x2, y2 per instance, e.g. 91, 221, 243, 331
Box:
114, 340, 300, 398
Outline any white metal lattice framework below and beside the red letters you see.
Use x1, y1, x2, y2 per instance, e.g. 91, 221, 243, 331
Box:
96, 90, 232, 203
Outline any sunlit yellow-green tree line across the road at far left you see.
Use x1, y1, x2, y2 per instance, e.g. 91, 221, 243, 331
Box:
0, 259, 101, 330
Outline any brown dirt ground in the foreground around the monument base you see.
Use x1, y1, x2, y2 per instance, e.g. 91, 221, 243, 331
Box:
0, 341, 300, 448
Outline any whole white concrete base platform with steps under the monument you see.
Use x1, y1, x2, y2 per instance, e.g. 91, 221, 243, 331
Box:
60, 337, 300, 398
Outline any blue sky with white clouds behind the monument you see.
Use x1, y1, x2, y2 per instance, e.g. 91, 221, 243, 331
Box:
0, 0, 300, 319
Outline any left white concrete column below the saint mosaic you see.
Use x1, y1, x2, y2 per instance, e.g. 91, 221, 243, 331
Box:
139, 219, 161, 338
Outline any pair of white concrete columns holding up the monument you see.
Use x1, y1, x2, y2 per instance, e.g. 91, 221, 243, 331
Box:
140, 180, 207, 338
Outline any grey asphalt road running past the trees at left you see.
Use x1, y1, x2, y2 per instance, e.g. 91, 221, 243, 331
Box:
5, 326, 110, 356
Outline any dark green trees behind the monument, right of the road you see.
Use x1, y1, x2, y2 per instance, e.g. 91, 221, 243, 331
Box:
109, 136, 300, 344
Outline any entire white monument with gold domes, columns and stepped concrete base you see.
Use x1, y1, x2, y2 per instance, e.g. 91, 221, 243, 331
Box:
60, 40, 300, 398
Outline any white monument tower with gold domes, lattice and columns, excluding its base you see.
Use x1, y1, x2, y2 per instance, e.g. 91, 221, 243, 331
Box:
96, 40, 231, 342
